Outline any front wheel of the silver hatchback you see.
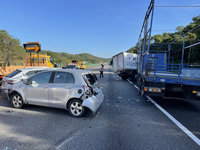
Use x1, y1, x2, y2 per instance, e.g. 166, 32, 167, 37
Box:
11, 93, 24, 109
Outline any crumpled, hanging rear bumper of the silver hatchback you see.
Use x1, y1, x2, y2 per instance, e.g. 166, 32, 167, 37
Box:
82, 92, 104, 113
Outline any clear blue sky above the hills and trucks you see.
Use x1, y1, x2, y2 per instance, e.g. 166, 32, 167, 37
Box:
0, 0, 200, 58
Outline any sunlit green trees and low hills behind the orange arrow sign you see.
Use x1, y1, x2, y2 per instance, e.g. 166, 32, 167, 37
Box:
0, 30, 110, 65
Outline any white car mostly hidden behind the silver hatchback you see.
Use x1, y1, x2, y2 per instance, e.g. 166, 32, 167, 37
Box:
1, 67, 49, 93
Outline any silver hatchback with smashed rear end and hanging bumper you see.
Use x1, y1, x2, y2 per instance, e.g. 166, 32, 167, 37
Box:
7, 69, 104, 117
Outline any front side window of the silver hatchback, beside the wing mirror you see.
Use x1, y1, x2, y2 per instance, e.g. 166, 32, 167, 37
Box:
32, 72, 52, 84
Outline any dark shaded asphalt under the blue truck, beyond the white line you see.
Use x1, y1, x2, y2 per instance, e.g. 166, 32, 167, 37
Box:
154, 97, 200, 139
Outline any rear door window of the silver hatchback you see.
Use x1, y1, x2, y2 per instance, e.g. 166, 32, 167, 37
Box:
53, 72, 75, 83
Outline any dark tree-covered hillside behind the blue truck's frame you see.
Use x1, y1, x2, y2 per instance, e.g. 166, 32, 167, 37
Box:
127, 15, 200, 64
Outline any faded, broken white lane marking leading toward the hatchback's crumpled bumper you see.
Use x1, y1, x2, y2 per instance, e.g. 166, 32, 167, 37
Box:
56, 111, 100, 150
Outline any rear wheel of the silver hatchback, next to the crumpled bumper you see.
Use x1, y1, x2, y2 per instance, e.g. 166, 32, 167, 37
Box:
68, 99, 85, 118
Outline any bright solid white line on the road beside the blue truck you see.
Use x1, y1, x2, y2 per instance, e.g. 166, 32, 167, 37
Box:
130, 84, 200, 146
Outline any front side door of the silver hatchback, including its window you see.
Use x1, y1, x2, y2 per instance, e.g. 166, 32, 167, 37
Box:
25, 71, 52, 106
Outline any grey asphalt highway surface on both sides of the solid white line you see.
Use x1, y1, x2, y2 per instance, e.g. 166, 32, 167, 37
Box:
0, 67, 200, 150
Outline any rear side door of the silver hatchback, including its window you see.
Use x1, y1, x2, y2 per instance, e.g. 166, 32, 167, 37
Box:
49, 71, 77, 109
